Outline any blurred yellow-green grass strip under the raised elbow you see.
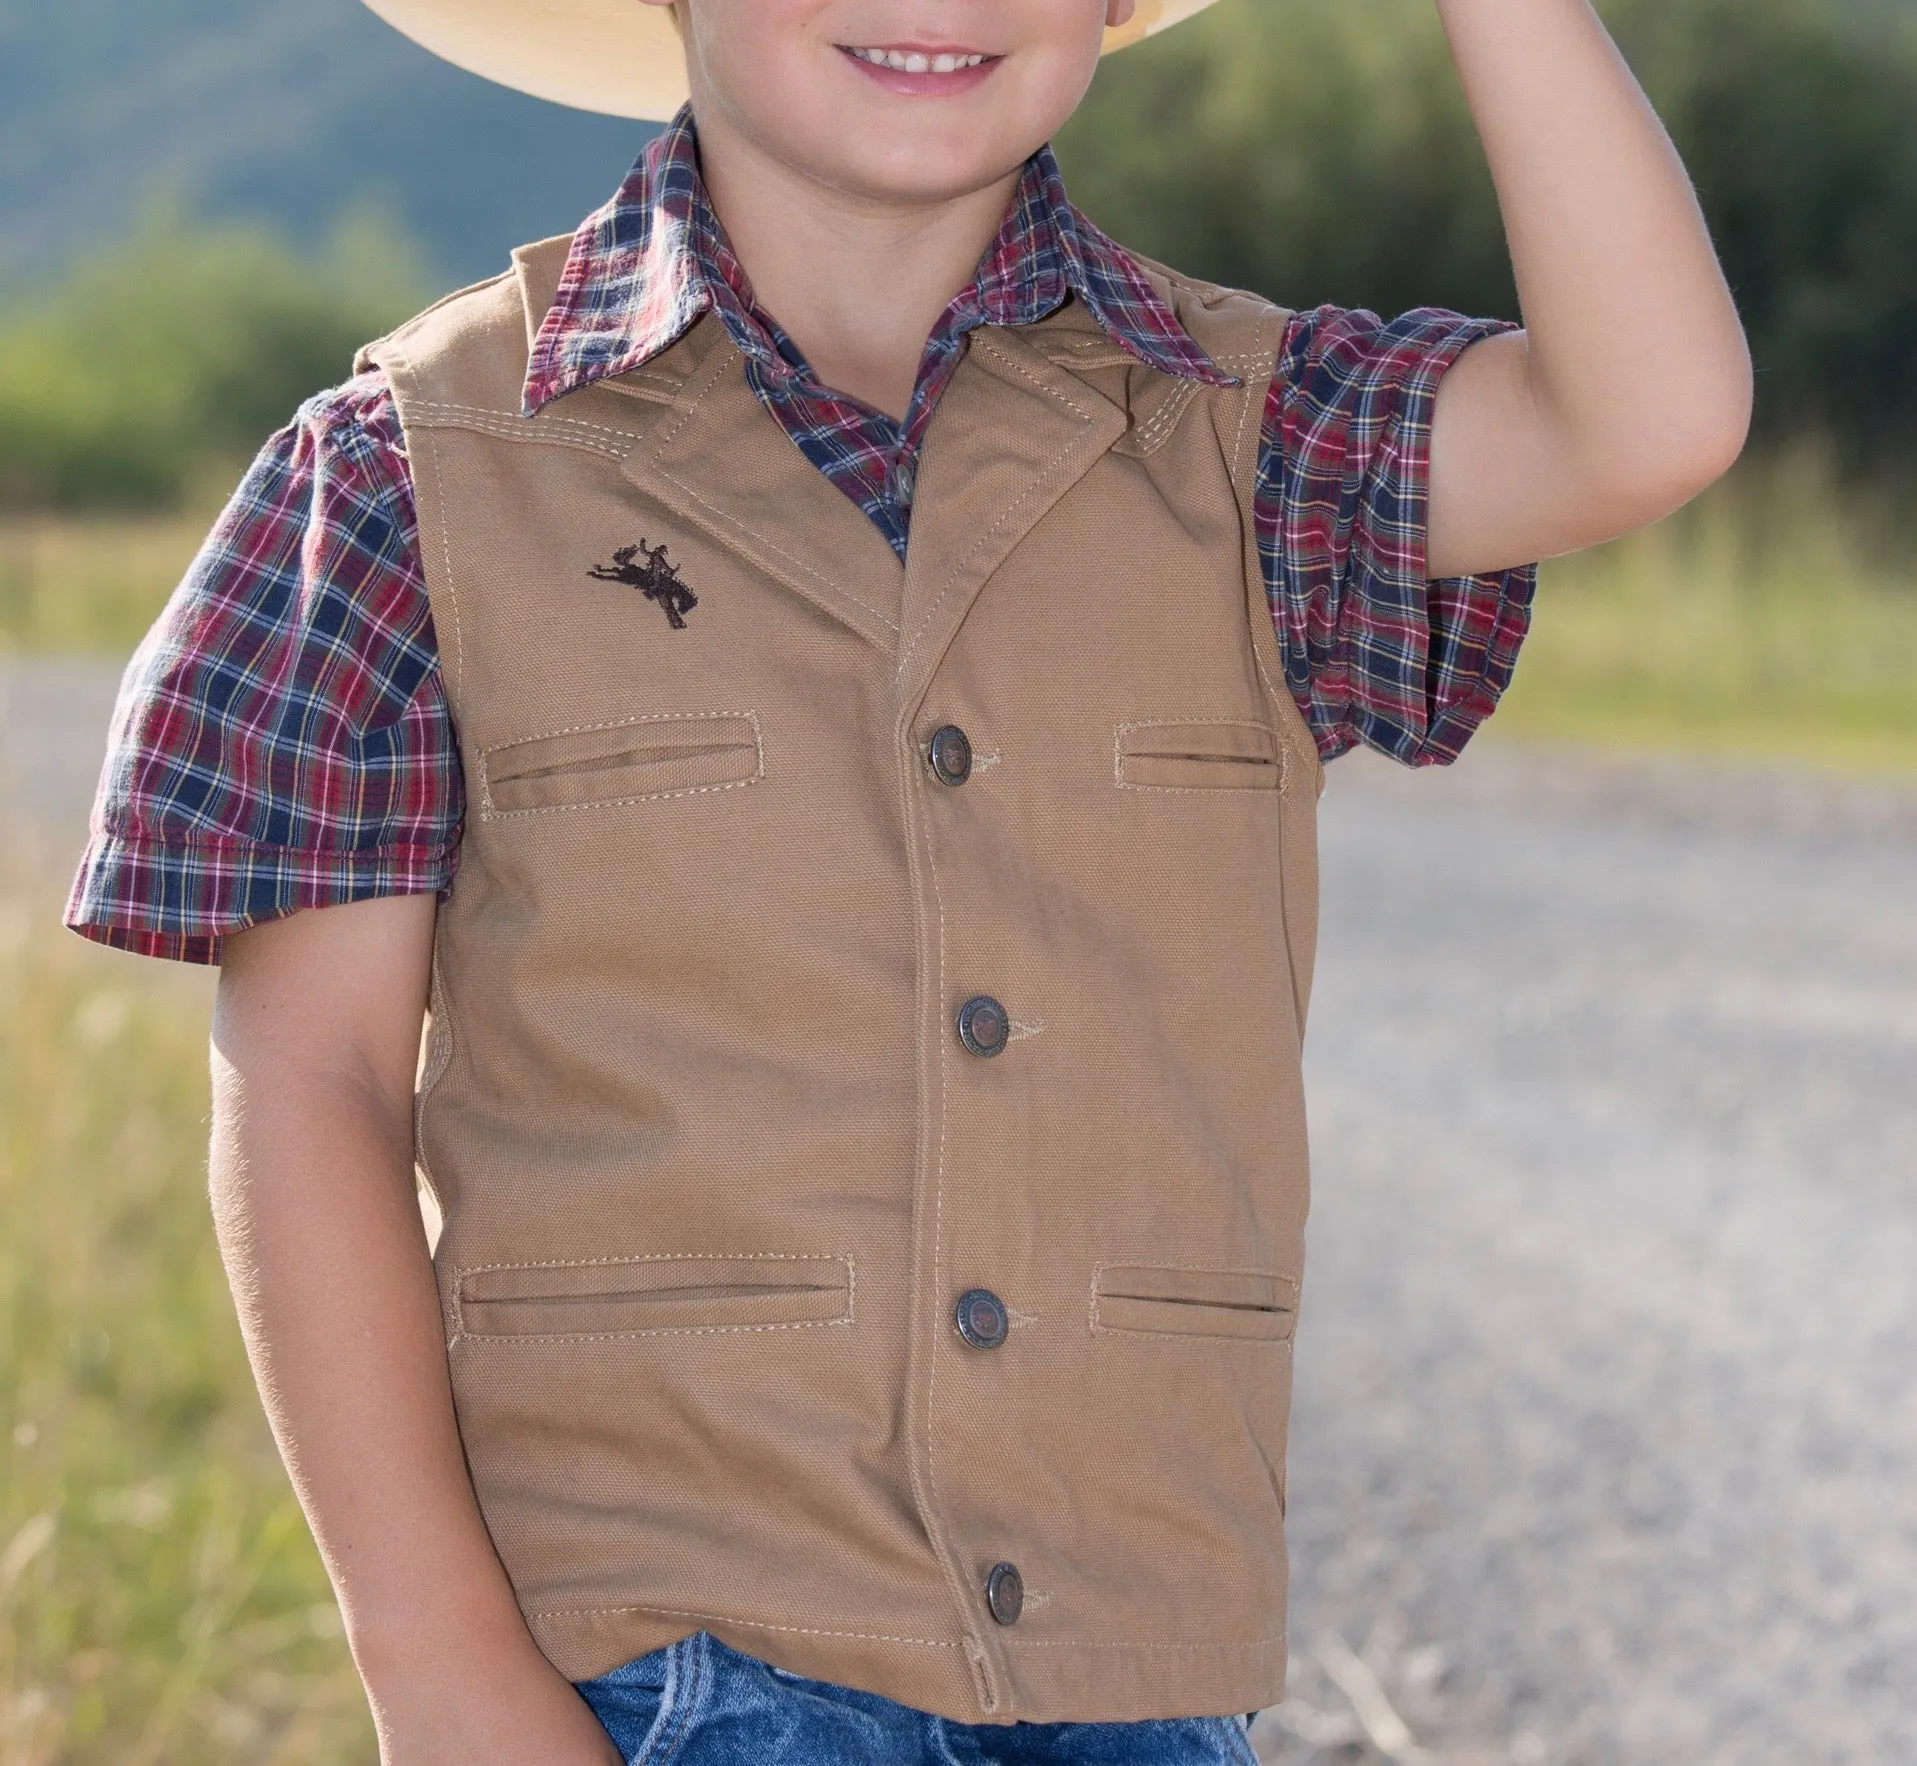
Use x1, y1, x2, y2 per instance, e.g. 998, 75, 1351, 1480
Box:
1490, 462, 1917, 775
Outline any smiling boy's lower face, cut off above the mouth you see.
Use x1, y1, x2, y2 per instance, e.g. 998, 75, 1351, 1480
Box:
646, 0, 1135, 203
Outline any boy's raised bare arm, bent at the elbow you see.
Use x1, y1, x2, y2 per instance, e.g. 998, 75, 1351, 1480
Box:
1430, 0, 1752, 577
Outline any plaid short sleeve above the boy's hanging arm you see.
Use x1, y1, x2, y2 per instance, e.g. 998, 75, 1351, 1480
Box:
65, 374, 464, 963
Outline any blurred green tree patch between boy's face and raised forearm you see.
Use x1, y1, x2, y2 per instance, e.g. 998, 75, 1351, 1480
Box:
1058, 0, 1514, 327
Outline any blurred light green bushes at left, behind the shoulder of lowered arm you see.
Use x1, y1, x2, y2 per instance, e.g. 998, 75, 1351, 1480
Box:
0, 219, 424, 510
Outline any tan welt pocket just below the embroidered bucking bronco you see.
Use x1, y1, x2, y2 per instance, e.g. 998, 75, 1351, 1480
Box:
479, 711, 765, 821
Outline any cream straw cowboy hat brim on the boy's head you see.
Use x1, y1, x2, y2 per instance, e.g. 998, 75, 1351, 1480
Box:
366, 0, 1212, 121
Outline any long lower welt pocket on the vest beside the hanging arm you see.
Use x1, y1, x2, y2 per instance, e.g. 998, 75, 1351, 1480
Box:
456, 1252, 853, 1338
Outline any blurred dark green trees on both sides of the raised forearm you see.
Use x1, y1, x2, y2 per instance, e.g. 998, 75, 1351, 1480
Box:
1058, 0, 1917, 464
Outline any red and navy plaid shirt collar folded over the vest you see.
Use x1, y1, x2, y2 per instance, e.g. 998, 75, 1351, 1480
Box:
523, 107, 1236, 416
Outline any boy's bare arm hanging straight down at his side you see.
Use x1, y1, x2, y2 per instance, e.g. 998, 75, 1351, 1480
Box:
213, 895, 617, 1766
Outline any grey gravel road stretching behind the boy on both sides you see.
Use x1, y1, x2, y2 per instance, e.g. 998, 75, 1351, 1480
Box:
0, 665, 1917, 1766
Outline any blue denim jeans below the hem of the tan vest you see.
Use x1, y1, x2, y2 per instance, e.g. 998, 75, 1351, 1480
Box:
579, 1632, 1258, 1766
